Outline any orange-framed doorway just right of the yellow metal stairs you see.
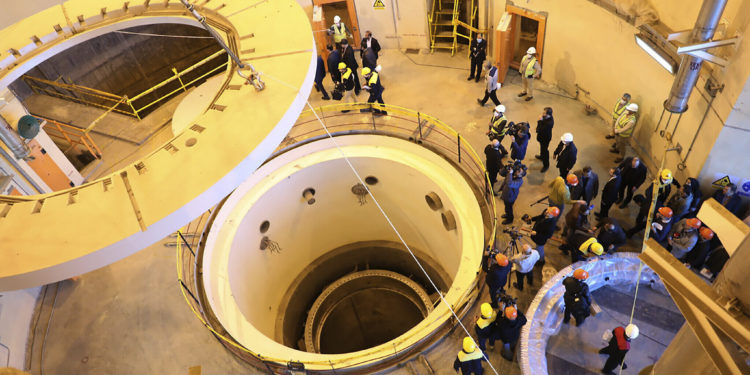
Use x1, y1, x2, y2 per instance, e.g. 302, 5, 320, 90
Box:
493, 5, 547, 83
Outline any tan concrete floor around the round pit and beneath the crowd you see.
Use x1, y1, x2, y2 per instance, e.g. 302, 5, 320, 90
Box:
22, 50, 681, 375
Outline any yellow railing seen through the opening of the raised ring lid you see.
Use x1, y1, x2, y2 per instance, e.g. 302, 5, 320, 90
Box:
23, 49, 229, 120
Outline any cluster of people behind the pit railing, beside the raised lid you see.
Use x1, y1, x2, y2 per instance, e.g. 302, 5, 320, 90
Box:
315, 16, 388, 115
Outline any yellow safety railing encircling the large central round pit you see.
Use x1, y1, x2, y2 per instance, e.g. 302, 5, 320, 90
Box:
174, 103, 497, 374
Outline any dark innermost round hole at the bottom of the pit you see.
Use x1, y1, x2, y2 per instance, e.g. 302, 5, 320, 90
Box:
320, 288, 424, 354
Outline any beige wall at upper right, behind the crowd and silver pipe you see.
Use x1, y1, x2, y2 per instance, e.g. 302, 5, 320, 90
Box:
480, 0, 750, 191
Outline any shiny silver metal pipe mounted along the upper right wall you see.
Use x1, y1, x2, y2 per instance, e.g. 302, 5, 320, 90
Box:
664, 0, 727, 113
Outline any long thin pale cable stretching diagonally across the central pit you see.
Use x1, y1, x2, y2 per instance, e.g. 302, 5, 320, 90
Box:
264, 73, 500, 375
